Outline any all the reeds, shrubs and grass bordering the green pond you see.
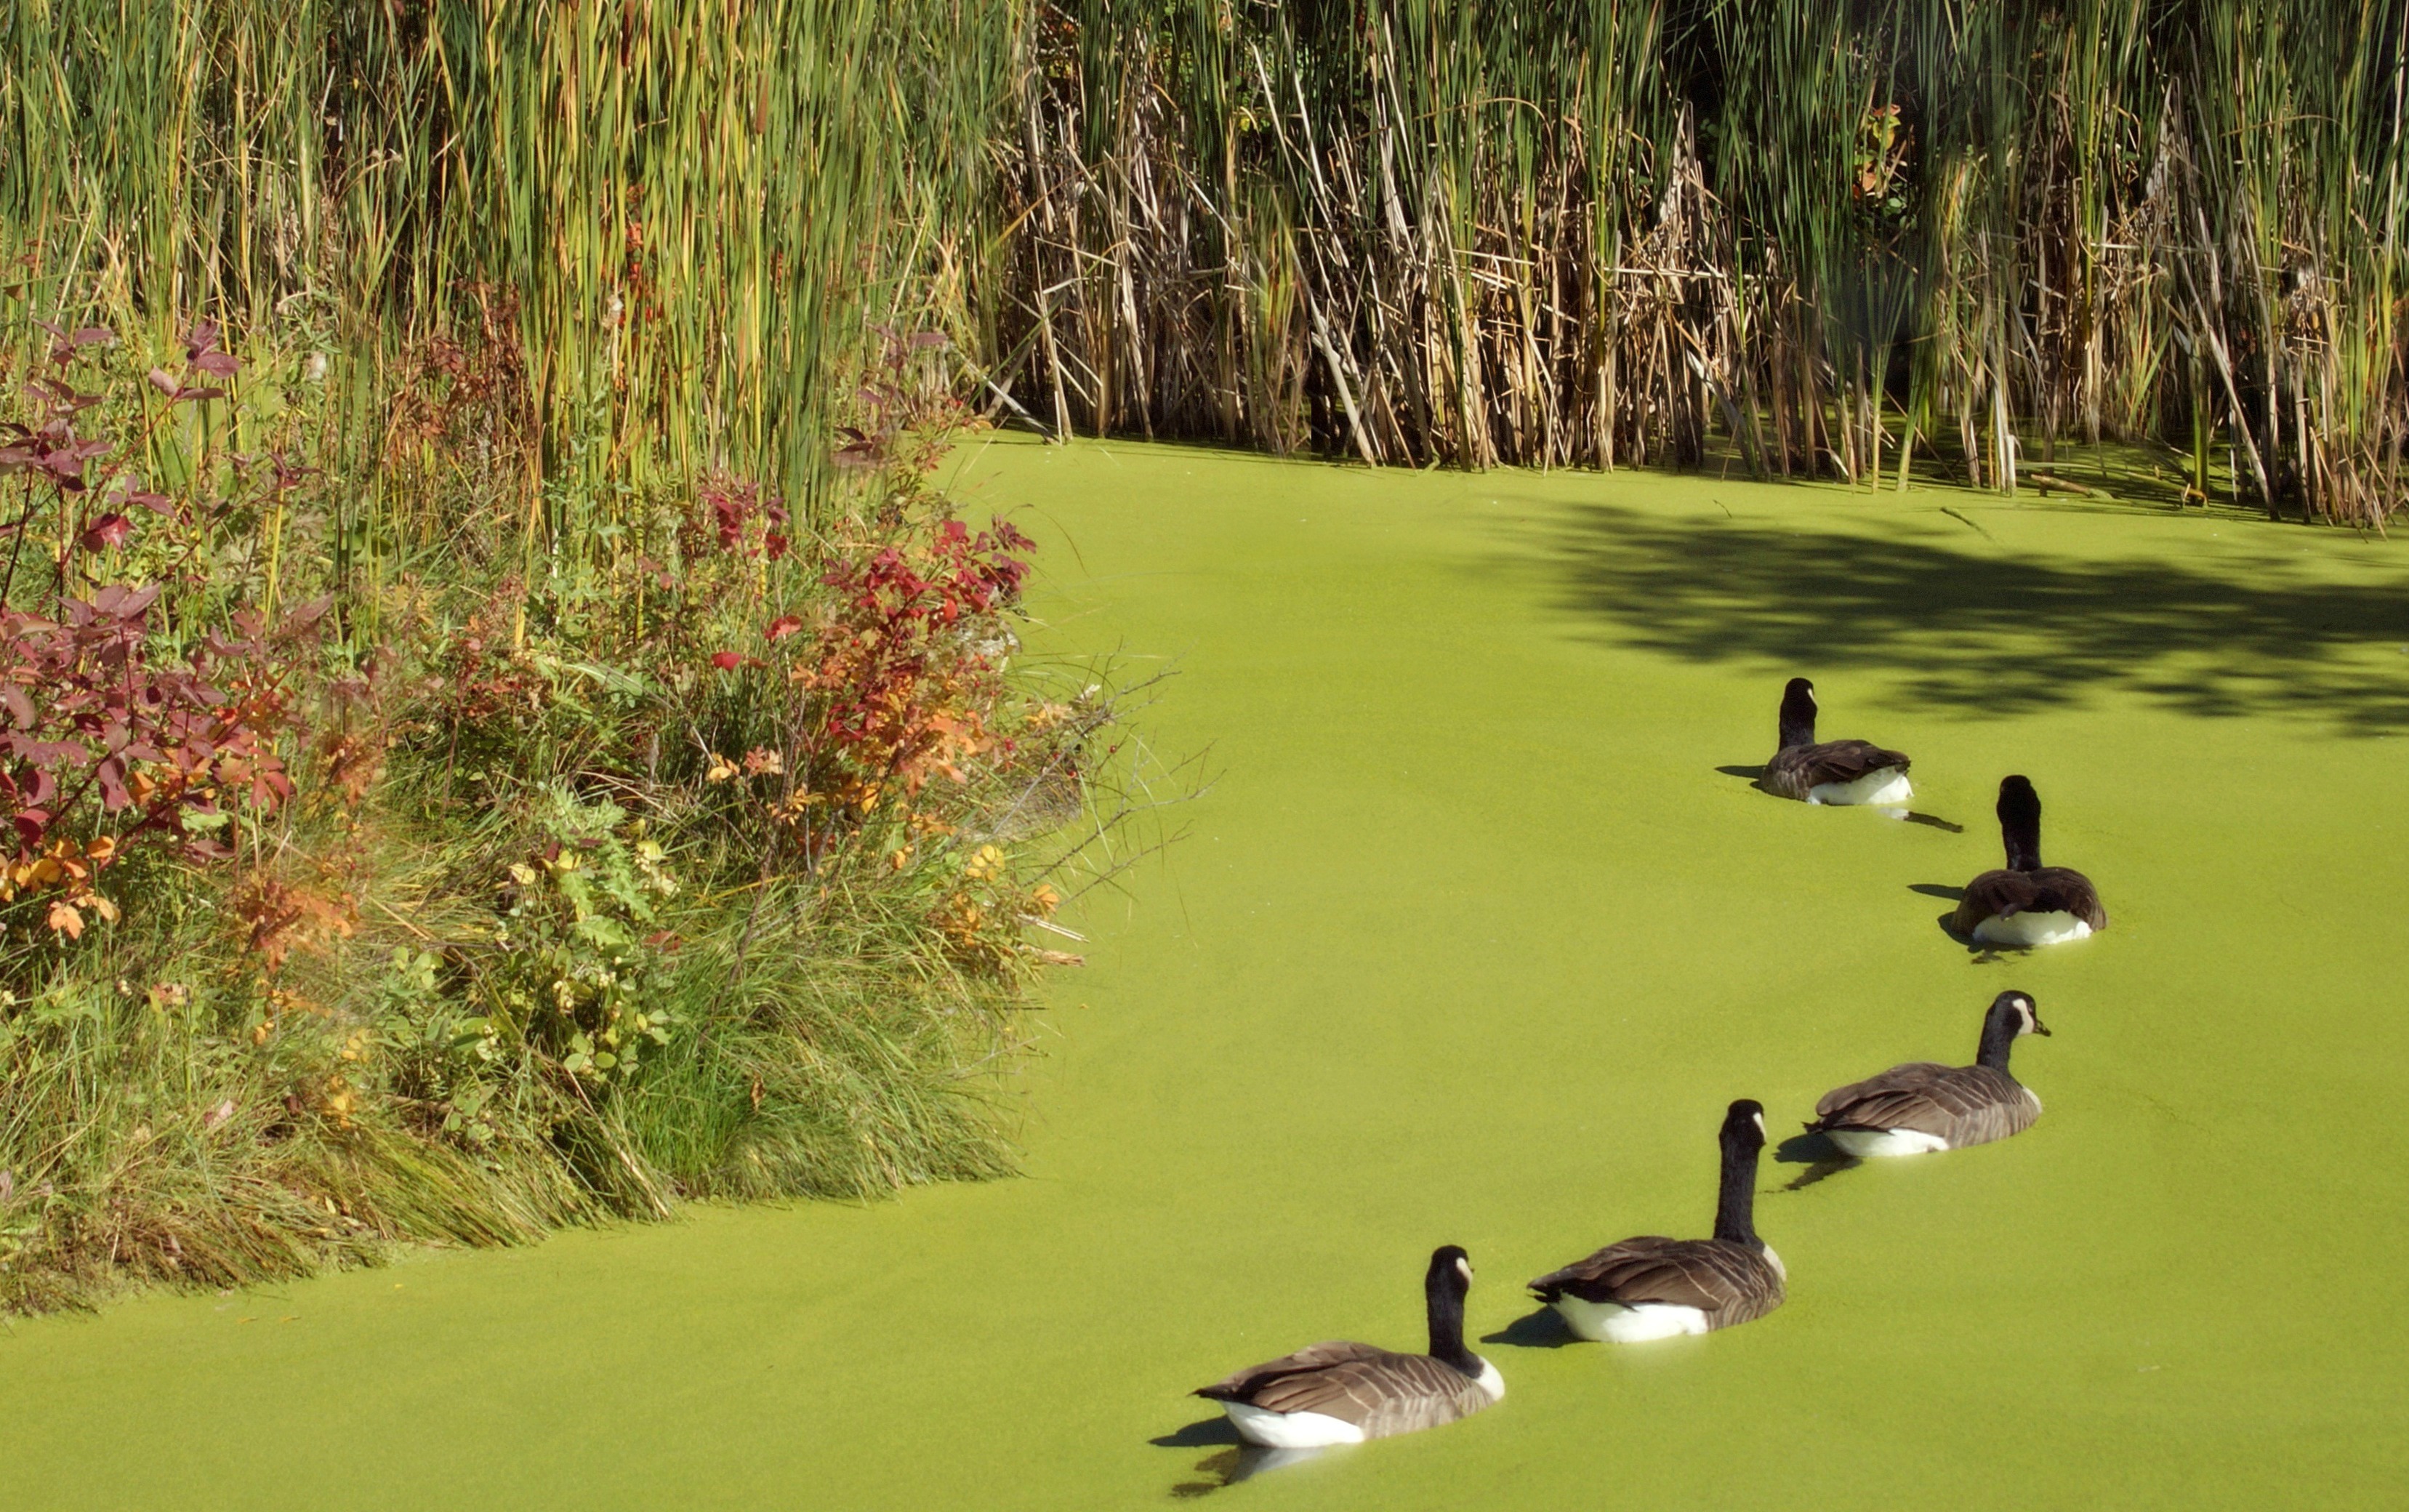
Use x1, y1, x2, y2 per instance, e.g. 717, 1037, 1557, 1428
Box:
0, 0, 2409, 1310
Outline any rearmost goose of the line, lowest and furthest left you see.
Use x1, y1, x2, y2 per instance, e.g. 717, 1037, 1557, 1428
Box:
1197, 1244, 1505, 1449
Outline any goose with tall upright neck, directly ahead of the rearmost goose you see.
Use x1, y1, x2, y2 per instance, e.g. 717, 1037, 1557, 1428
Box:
1529, 1098, 1785, 1343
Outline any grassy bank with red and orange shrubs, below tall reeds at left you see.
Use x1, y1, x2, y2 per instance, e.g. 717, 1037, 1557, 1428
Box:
0, 315, 1141, 1310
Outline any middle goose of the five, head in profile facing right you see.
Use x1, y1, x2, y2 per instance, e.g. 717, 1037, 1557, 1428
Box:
1807, 992, 2050, 1160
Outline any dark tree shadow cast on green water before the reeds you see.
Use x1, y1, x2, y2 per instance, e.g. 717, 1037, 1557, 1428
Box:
1547, 501, 2409, 731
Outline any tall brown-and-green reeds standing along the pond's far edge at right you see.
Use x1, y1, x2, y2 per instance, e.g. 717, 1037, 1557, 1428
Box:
985, 0, 2409, 523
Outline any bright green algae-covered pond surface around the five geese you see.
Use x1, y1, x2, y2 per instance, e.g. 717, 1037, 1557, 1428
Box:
0, 441, 2409, 1510
